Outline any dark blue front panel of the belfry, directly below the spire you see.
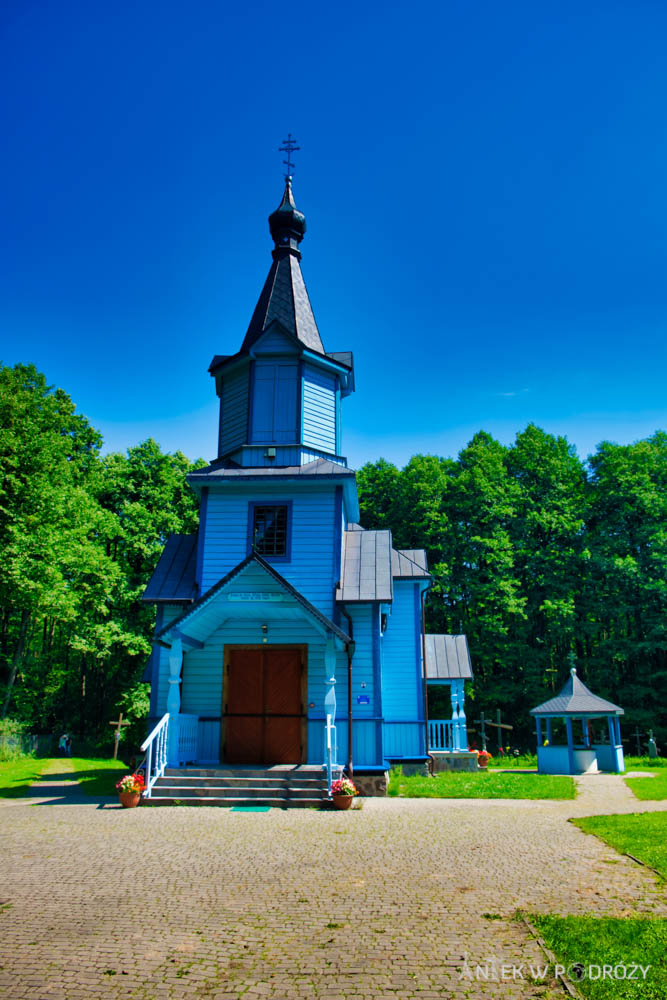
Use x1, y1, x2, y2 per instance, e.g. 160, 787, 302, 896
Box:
251, 360, 298, 444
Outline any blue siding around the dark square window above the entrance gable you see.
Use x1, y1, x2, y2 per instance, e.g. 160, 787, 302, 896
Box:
202, 483, 337, 617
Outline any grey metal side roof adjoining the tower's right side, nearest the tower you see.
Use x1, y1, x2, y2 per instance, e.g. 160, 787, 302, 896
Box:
336, 526, 394, 603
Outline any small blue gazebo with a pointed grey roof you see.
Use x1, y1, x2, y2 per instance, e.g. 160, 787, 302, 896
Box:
530, 667, 625, 774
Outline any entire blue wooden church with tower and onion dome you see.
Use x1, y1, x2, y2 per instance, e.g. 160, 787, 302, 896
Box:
143, 176, 470, 792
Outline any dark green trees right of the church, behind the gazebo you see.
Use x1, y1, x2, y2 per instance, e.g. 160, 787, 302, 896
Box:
358, 424, 667, 753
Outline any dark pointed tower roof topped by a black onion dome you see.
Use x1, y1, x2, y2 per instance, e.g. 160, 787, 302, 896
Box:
241, 176, 325, 354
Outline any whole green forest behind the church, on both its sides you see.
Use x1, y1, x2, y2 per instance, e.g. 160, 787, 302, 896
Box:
0, 365, 667, 749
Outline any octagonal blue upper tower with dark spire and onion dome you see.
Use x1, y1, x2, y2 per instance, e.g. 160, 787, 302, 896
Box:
209, 175, 354, 467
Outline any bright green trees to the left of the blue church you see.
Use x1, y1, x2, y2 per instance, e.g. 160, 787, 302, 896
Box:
0, 365, 202, 745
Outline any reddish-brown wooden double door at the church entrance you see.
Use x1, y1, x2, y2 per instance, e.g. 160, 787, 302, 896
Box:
221, 646, 307, 764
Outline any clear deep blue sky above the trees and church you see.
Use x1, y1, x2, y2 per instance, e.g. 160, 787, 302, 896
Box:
0, 0, 667, 466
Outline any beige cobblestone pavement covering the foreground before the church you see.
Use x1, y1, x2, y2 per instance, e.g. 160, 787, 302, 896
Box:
0, 776, 667, 1000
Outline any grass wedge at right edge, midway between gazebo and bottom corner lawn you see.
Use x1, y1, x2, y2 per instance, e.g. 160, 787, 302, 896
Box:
571, 812, 667, 876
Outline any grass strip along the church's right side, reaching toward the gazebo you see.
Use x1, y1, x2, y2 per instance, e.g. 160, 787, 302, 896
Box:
388, 769, 576, 799
